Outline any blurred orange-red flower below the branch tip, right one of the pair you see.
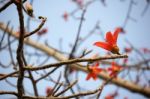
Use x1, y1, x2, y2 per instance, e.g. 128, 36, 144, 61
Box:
108, 62, 122, 77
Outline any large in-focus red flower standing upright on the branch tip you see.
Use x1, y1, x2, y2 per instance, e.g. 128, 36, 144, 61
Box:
94, 28, 121, 54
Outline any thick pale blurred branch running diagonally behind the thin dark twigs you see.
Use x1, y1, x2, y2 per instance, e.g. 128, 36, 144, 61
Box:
0, 23, 150, 97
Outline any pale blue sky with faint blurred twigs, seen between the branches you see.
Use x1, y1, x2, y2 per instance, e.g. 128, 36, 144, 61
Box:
0, 0, 150, 99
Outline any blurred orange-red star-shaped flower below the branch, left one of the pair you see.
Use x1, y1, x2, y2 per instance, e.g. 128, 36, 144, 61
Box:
86, 62, 102, 80
